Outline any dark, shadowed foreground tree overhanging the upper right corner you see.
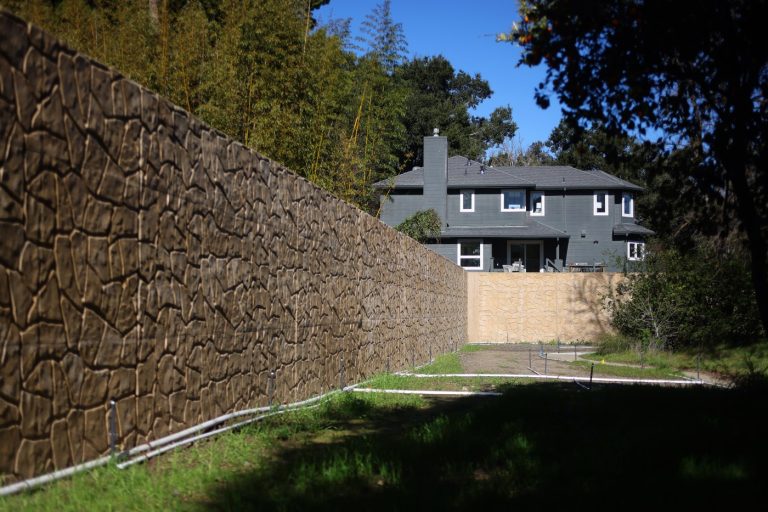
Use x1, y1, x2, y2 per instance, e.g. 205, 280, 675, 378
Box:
502, 0, 768, 334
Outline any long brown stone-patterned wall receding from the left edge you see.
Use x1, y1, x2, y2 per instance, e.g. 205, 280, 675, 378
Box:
0, 13, 466, 482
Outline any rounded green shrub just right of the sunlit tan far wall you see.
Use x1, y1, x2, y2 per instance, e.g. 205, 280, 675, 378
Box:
606, 243, 763, 349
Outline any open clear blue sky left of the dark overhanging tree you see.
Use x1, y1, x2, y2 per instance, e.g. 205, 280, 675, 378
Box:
315, 0, 561, 147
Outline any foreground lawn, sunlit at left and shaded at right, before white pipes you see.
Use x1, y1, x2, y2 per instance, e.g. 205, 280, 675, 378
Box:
0, 383, 768, 512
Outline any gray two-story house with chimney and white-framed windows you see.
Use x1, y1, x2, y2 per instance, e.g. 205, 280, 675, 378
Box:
375, 135, 653, 272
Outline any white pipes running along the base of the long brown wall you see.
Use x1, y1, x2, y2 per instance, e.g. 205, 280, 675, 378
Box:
0, 383, 354, 496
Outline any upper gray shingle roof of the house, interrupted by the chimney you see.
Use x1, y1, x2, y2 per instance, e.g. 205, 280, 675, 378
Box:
374, 156, 643, 191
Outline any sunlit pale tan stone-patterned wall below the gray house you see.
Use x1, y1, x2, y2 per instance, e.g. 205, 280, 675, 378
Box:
467, 272, 623, 342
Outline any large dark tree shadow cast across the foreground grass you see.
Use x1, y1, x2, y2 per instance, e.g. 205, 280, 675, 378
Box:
201, 384, 768, 510
